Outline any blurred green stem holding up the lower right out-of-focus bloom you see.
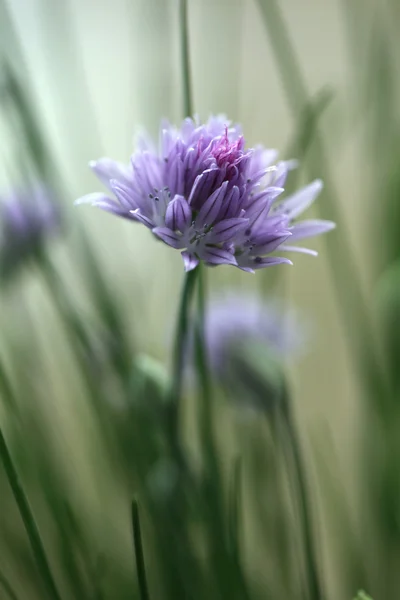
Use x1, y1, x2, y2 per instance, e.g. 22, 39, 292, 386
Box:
279, 384, 325, 600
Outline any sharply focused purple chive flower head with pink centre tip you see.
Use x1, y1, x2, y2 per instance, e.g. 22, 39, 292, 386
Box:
77, 116, 334, 272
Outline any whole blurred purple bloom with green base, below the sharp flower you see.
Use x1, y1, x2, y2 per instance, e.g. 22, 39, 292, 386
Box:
205, 292, 309, 415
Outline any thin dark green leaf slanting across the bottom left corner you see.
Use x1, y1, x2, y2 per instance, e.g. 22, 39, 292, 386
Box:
0, 429, 61, 600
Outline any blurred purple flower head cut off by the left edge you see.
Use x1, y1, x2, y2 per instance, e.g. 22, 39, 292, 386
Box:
0, 184, 61, 275
